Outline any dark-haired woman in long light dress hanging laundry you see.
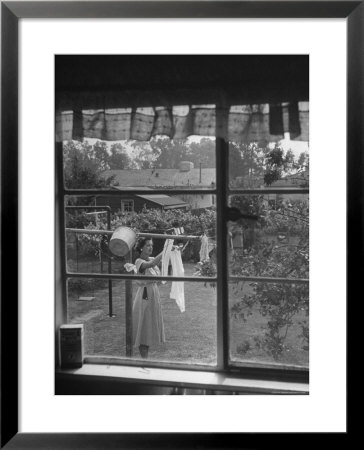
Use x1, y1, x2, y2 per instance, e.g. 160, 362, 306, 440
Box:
133, 238, 165, 358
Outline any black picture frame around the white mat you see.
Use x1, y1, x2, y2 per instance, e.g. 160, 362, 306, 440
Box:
1, 0, 356, 449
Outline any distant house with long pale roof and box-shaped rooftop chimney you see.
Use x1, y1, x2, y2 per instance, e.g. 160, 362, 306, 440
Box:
103, 161, 216, 211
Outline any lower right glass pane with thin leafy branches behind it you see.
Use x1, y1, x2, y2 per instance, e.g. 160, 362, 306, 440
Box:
229, 282, 309, 367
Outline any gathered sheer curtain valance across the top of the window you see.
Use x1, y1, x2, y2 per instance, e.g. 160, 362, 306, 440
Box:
56, 102, 309, 143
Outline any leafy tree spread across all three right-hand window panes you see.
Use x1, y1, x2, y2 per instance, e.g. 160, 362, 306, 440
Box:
225, 143, 309, 360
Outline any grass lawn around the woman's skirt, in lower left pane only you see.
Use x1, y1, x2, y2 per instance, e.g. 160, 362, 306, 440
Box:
68, 264, 216, 364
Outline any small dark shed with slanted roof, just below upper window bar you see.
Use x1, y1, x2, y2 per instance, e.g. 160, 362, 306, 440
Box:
95, 186, 190, 212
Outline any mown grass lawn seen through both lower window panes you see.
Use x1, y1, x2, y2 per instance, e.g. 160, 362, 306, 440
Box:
68, 263, 308, 366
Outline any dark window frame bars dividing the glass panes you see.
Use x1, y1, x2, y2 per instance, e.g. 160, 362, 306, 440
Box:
56, 57, 309, 382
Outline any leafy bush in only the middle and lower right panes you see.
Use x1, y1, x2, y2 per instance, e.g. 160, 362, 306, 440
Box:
230, 202, 309, 360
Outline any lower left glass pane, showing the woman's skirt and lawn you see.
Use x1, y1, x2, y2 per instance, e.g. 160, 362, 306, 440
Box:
68, 278, 216, 365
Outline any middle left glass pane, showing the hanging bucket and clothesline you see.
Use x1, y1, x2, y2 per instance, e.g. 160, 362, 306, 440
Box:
65, 194, 216, 277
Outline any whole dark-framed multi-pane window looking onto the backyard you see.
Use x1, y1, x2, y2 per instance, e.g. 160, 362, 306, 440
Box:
56, 56, 309, 392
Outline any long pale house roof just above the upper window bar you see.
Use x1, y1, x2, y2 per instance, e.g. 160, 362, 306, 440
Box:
102, 168, 216, 189
